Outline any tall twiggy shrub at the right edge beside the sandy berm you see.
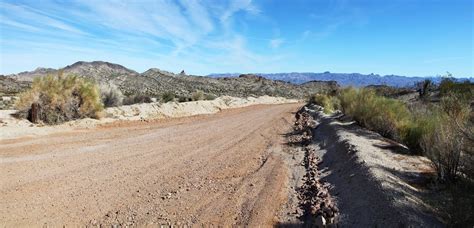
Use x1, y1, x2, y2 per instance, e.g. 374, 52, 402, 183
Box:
421, 93, 474, 182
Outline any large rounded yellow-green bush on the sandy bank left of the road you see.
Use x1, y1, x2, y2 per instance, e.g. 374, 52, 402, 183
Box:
16, 73, 103, 124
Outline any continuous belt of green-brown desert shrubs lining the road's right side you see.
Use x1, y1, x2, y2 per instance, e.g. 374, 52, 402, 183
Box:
309, 77, 474, 226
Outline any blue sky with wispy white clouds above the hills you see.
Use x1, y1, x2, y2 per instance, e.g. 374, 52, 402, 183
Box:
0, 0, 474, 77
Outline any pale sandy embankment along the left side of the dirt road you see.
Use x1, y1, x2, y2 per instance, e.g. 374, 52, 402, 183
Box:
0, 96, 298, 140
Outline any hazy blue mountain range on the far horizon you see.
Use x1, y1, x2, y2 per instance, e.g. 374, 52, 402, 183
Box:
208, 71, 474, 87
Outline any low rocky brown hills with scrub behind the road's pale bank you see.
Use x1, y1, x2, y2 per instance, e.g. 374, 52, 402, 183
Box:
0, 61, 339, 101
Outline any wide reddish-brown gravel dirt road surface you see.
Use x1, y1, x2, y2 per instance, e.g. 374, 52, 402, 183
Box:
0, 104, 301, 226
